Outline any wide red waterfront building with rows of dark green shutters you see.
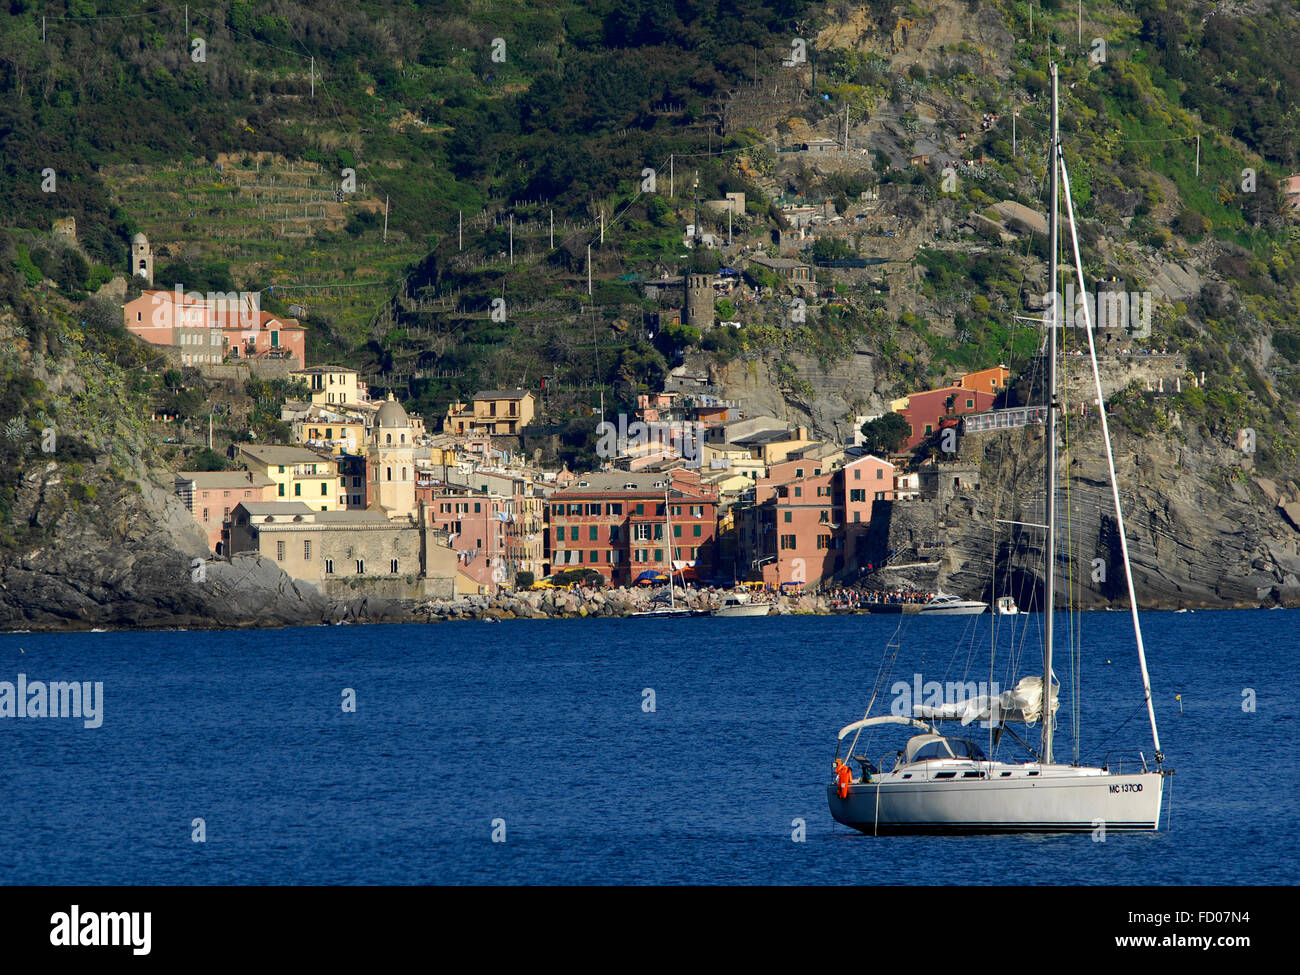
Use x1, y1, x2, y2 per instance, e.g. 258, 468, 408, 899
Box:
547, 471, 718, 585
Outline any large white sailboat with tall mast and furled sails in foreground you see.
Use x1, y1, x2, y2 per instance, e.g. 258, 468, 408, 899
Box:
827, 64, 1171, 835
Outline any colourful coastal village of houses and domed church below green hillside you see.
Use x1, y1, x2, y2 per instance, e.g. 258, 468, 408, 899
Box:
114, 206, 1179, 618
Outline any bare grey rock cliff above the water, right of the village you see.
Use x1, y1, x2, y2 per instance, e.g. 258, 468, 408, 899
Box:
871, 425, 1300, 608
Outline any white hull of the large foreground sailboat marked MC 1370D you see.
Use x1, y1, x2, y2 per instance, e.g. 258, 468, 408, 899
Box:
827, 763, 1165, 836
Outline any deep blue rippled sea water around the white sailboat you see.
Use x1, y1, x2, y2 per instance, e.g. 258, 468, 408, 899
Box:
0, 611, 1300, 885
